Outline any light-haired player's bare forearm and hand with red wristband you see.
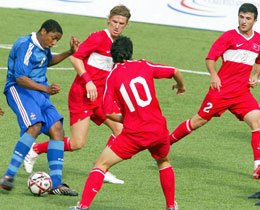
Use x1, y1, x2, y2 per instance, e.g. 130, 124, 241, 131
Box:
70, 56, 98, 101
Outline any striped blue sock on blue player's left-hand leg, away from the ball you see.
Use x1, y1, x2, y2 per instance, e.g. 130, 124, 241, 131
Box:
5, 133, 35, 177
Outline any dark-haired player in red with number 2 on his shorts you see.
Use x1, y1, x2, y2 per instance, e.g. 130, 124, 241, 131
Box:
170, 3, 260, 179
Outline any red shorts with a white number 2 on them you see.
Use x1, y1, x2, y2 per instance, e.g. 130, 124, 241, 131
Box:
198, 92, 260, 121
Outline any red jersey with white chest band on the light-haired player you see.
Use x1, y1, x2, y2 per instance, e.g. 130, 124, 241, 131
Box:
69, 29, 114, 113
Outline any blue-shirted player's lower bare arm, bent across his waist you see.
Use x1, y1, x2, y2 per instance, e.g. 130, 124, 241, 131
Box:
16, 76, 60, 95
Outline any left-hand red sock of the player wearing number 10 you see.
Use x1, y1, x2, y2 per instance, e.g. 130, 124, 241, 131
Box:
79, 168, 105, 208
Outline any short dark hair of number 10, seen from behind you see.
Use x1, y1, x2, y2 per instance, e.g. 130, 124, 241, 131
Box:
111, 36, 133, 63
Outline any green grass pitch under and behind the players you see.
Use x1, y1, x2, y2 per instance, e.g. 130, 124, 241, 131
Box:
0, 8, 260, 210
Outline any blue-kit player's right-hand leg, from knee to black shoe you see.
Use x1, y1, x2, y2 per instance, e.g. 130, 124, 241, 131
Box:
47, 120, 78, 196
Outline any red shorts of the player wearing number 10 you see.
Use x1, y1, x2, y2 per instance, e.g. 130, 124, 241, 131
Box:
107, 131, 170, 160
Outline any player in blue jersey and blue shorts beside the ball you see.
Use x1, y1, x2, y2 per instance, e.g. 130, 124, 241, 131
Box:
0, 19, 79, 196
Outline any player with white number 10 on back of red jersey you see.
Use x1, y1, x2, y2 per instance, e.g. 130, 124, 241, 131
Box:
67, 36, 185, 210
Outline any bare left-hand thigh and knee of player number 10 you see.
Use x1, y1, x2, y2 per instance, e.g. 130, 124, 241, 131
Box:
94, 147, 123, 171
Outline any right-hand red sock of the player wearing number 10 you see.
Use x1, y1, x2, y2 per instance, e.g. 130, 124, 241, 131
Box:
160, 166, 175, 209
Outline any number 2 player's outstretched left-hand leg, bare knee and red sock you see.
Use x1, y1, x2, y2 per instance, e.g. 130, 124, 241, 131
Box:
170, 114, 208, 144
